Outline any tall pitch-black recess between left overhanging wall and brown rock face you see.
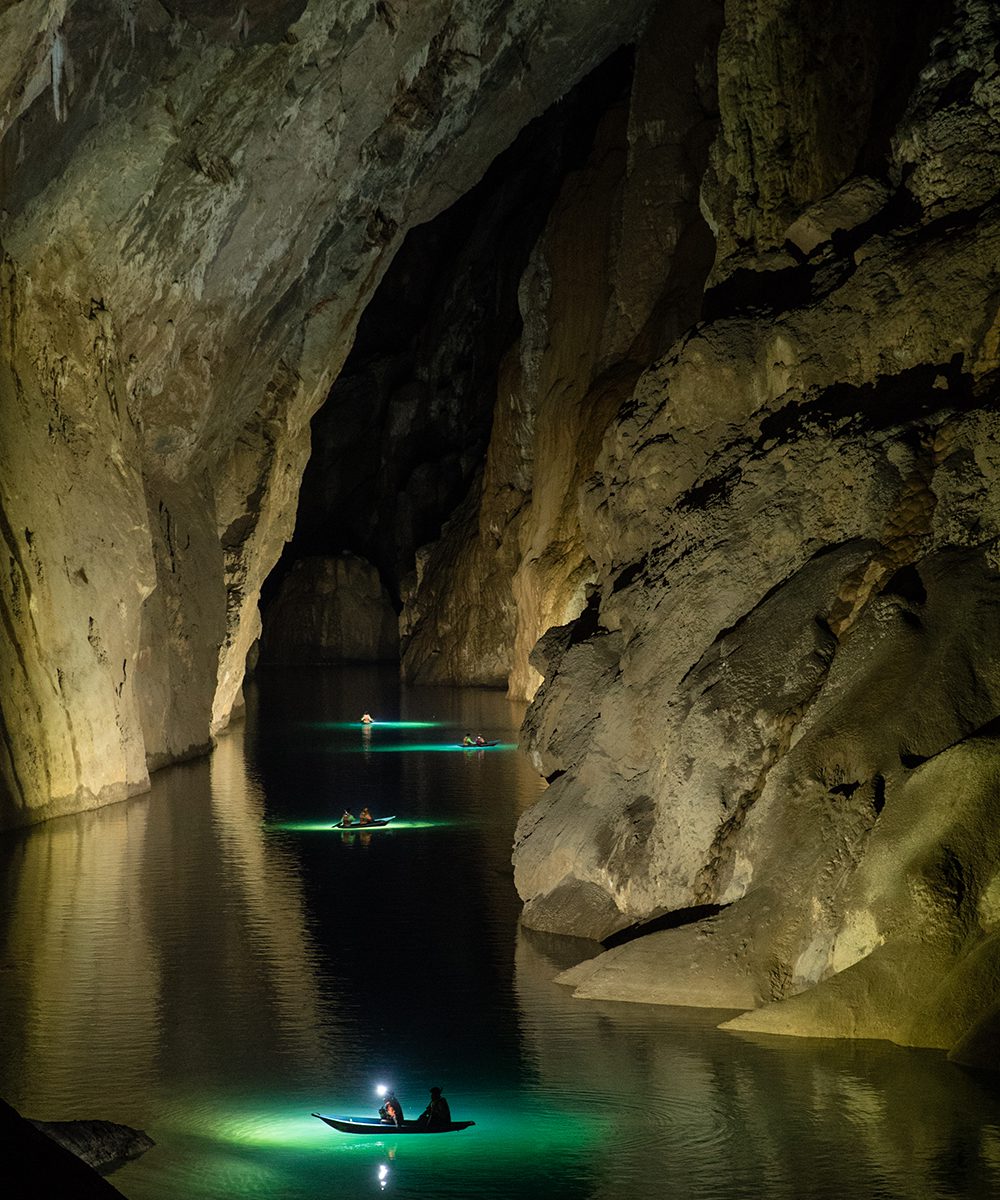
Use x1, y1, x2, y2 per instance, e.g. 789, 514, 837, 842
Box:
262, 48, 633, 609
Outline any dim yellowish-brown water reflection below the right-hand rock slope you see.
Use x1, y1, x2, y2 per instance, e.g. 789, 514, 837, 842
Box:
516, 931, 1000, 1200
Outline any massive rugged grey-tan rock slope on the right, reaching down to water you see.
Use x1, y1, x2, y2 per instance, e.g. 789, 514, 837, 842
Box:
515, 2, 1000, 1061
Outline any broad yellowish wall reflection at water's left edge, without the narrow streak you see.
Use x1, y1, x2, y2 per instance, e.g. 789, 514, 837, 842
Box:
0, 804, 163, 1118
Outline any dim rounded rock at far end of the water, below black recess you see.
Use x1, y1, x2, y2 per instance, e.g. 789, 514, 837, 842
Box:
261, 554, 400, 664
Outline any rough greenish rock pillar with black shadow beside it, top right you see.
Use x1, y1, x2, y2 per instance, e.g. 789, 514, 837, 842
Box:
702, 0, 945, 281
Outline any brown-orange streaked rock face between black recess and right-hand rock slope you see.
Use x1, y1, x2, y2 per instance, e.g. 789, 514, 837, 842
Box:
402, 2, 720, 698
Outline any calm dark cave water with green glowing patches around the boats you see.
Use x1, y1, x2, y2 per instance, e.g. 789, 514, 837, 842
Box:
0, 668, 1000, 1200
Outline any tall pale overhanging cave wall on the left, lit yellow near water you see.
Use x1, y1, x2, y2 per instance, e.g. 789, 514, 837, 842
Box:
0, 0, 648, 826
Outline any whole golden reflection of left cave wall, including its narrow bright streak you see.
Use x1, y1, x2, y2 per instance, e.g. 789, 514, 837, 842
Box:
0, 715, 325, 1123
